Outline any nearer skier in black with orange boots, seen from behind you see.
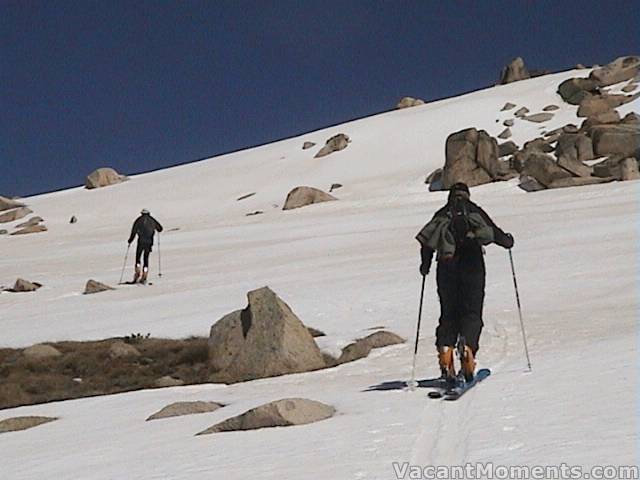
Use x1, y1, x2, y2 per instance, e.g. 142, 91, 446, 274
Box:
416, 183, 513, 380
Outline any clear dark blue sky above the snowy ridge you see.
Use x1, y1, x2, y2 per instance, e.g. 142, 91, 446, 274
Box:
0, 0, 640, 195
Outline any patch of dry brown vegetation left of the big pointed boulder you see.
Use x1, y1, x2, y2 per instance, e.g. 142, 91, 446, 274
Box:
0, 336, 208, 409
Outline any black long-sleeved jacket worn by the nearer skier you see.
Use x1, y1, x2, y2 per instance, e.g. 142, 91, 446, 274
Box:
416, 200, 513, 264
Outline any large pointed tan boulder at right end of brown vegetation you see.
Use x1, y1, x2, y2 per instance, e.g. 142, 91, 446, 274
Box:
209, 287, 326, 383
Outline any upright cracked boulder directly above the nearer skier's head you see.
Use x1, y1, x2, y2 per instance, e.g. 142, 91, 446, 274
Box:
442, 128, 500, 189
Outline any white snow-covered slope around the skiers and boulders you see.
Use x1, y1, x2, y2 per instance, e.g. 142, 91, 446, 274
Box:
0, 70, 640, 479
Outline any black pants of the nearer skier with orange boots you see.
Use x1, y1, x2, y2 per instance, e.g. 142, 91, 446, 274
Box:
436, 258, 485, 354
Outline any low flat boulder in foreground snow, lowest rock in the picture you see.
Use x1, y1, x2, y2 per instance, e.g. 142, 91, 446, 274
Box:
197, 398, 336, 435
